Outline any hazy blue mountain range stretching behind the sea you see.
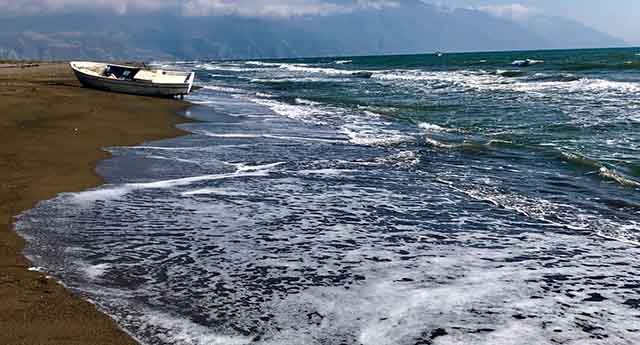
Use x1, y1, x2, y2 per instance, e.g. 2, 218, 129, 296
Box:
0, 0, 625, 60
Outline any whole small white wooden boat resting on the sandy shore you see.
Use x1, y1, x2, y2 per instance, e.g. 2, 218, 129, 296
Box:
69, 61, 195, 97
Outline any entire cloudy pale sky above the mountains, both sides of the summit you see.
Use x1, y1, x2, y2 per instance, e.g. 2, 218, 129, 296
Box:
0, 0, 640, 46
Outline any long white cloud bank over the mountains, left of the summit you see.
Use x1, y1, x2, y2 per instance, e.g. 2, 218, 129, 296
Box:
0, 0, 398, 17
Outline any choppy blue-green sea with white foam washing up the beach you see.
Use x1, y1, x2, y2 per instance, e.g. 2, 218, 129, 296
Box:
17, 49, 640, 345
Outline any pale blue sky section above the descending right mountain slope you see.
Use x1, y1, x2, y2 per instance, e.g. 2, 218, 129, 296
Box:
432, 0, 640, 46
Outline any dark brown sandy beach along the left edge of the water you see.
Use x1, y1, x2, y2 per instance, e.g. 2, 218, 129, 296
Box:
0, 63, 187, 345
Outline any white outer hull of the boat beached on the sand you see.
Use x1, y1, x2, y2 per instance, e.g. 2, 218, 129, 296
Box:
71, 63, 195, 97
